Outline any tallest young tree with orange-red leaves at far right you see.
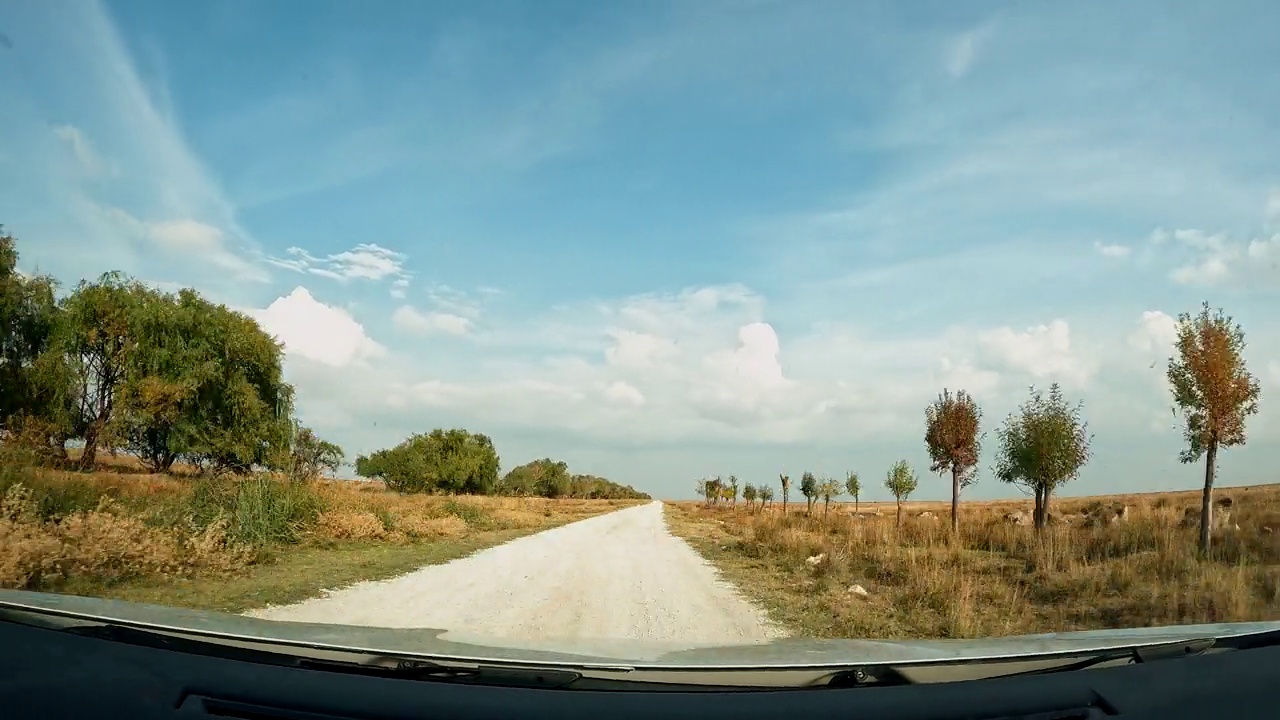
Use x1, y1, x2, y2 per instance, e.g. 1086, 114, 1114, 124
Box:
1167, 302, 1262, 555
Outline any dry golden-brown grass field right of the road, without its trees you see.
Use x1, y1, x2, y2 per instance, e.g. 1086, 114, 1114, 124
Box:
667, 486, 1280, 638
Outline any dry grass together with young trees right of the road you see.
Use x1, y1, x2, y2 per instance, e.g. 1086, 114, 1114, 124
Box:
667, 304, 1280, 638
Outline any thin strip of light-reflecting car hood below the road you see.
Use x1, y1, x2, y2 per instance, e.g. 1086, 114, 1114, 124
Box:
0, 591, 1280, 670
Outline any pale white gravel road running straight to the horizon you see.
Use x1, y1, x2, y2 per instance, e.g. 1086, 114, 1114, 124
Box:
240, 502, 783, 646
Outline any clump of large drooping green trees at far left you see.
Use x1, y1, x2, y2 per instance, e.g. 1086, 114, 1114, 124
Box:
0, 233, 343, 474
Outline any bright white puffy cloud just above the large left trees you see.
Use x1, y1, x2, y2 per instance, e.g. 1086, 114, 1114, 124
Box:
248, 286, 387, 368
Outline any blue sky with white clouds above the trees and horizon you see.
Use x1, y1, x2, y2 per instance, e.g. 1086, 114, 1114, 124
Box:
0, 0, 1280, 500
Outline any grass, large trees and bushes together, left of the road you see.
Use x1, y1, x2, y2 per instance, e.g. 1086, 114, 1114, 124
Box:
0, 234, 648, 610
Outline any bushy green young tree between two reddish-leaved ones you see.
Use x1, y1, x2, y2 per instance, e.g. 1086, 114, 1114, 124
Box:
995, 383, 1093, 530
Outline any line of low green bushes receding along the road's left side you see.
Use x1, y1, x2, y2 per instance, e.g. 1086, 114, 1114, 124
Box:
356, 428, 649, 500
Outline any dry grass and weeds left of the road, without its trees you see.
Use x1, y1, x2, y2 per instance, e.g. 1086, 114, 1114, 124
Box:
0, 457, 637, 611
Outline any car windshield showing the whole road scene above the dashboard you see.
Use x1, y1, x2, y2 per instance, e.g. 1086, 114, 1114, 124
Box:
0, 0, 1280, 662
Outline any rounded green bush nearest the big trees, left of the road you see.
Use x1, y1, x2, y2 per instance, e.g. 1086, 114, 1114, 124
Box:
356, 428, 499, 495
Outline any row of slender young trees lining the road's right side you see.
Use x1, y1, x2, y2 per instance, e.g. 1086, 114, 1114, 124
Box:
698, 302, 1261, 553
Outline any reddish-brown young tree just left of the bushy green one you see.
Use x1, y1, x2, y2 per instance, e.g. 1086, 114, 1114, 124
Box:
924, 388, 982, 533
